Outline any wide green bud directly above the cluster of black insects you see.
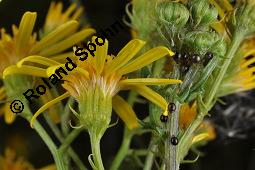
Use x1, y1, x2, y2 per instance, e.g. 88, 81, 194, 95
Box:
184, 31, 227, 56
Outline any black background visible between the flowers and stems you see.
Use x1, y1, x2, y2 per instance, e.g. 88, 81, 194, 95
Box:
0, 0, 255, 170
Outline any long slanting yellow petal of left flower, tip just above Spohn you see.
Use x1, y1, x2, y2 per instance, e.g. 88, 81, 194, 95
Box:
39, 28, 95, 56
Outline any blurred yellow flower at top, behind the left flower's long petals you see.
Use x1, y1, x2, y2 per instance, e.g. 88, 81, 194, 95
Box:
43, 2, 83, 34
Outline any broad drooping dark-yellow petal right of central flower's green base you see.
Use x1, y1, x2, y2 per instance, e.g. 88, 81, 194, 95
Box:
112, 95, 138, 129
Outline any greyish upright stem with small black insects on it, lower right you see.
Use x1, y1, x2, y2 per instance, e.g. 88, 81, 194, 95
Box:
165, 101, 181, 170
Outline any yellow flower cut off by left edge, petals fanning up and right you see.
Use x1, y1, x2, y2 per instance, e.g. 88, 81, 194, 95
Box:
0, 12, 95, 123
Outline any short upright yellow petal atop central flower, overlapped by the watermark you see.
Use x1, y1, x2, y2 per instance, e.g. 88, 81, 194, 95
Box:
93, 37, 108, 74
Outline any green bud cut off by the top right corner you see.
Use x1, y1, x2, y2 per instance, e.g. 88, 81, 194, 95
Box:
229, 0, 255, 37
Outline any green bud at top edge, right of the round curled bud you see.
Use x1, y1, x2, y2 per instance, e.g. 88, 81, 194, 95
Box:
188, 0, 218, 26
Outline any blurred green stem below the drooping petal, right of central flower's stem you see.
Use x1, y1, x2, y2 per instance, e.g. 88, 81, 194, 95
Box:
110, 126, 133, 170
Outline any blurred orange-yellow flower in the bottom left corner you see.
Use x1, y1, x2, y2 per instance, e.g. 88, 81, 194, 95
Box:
0, 148, 56, 170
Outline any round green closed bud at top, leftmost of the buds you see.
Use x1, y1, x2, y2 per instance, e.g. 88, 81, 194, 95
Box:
156, 1, 189, 30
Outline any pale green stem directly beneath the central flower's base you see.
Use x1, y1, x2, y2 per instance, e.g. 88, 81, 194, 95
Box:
89, 133, 104, 170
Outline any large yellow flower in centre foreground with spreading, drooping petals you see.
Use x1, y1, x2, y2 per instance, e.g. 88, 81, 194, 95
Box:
5, 37, 181, 128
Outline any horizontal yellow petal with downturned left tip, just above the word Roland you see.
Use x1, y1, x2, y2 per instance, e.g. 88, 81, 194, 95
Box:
3, 65, 48, 78
